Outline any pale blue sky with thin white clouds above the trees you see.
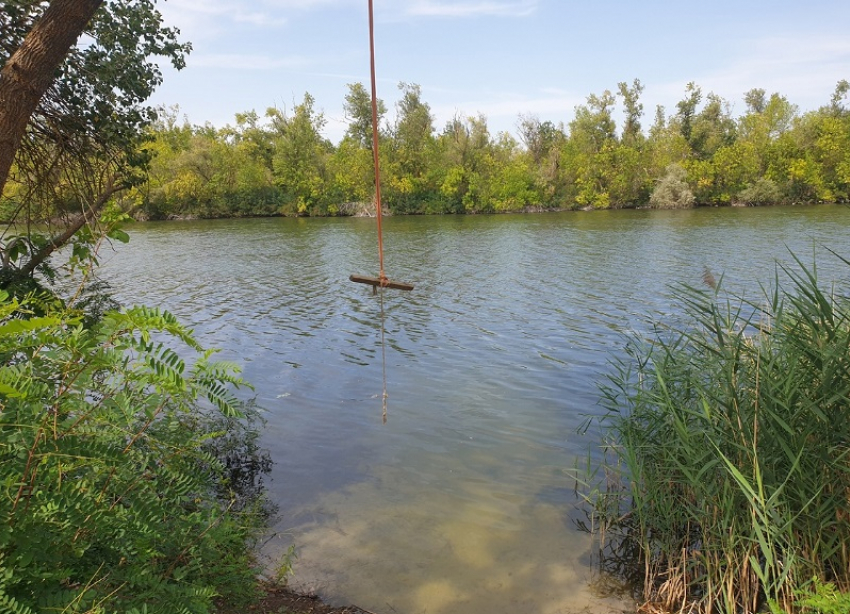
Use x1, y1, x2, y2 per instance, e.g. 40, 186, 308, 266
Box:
150, 0, 850, 143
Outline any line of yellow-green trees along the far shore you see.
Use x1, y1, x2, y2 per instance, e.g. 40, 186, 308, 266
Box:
116, 79, 850, 219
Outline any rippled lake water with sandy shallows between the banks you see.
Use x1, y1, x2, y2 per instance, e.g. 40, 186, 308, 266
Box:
102, 206, 850, 614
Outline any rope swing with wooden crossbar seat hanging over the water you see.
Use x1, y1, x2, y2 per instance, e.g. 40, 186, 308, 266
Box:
349, 0, 413, 424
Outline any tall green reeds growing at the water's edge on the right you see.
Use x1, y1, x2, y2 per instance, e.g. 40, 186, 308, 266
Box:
595, 254, 850, 614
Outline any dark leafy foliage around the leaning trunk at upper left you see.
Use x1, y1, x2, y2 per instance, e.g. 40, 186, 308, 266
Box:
0, 0, 190, 287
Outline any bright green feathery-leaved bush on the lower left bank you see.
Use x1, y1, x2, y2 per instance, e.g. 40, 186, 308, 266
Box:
0, 293, 270, 614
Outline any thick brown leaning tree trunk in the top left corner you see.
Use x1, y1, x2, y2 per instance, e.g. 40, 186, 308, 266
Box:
0, 0, 103, 194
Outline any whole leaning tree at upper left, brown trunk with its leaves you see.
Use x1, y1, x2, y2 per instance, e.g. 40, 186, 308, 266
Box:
0, 0, 190, 283
